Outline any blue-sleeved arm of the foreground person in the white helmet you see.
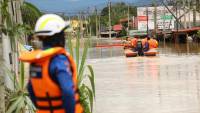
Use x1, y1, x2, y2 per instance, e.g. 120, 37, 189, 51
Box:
50, 55, 75, 113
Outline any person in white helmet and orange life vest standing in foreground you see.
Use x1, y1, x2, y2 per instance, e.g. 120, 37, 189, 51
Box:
19, 14, 83, 113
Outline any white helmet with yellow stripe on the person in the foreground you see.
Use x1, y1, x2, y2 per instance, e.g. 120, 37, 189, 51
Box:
35, 14, 69, 36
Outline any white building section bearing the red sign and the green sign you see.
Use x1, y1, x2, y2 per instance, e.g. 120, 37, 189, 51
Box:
137, 6, 175, 30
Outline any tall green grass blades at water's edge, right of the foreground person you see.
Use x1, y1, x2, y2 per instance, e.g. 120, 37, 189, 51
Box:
67, 33, 95, 113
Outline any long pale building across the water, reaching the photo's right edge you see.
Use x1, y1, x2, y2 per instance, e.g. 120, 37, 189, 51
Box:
137, 6, 200, 31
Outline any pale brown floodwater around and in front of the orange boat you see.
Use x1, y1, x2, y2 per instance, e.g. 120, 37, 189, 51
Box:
88, 40, 200, 113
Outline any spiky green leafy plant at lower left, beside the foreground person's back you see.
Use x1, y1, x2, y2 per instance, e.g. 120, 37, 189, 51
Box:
2, 63, 35, 113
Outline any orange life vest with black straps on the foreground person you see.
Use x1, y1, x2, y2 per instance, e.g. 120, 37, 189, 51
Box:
19, 47, 83, 113
